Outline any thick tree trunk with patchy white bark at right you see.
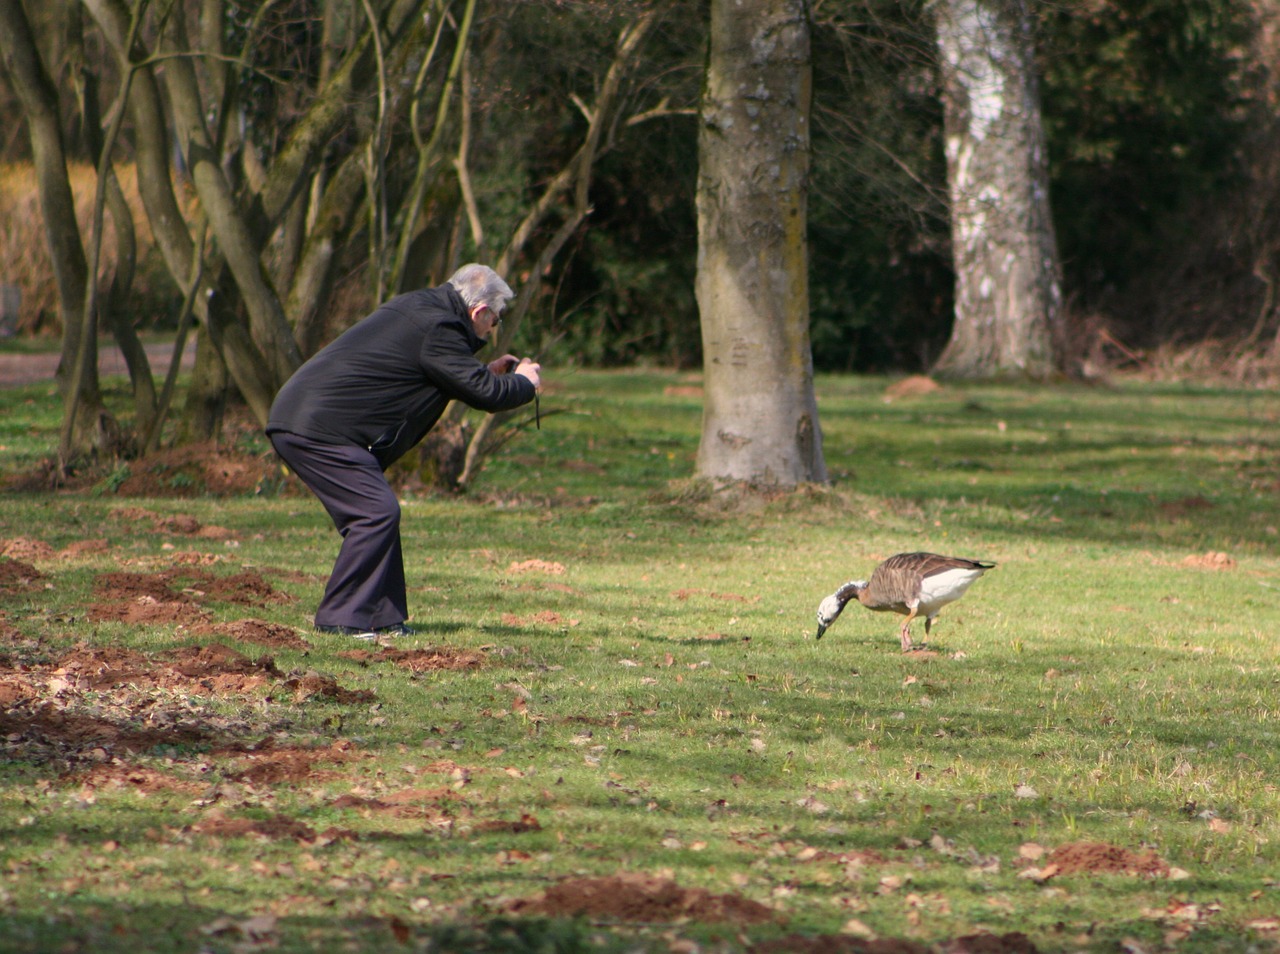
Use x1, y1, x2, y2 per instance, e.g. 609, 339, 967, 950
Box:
934, 0, 1062, 379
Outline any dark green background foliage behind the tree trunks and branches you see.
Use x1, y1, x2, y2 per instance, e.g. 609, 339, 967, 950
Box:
0, 0, 1280, 371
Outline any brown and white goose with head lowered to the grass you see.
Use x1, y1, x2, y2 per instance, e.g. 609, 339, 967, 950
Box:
815, 553, 995, 653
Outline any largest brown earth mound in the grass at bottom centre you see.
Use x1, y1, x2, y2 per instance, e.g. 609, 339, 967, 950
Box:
507, 873, 774, 925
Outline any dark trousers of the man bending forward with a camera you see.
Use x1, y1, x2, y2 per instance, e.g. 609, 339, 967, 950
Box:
270, 430, 408, 629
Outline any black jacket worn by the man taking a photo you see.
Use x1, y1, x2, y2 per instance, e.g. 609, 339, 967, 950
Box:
266, 284, 535, 470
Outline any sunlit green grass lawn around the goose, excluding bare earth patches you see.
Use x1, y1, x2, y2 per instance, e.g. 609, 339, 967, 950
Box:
0, 371, 1280, 951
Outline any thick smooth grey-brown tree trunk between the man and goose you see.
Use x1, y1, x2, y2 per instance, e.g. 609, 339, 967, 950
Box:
696, 0, 827, 485
